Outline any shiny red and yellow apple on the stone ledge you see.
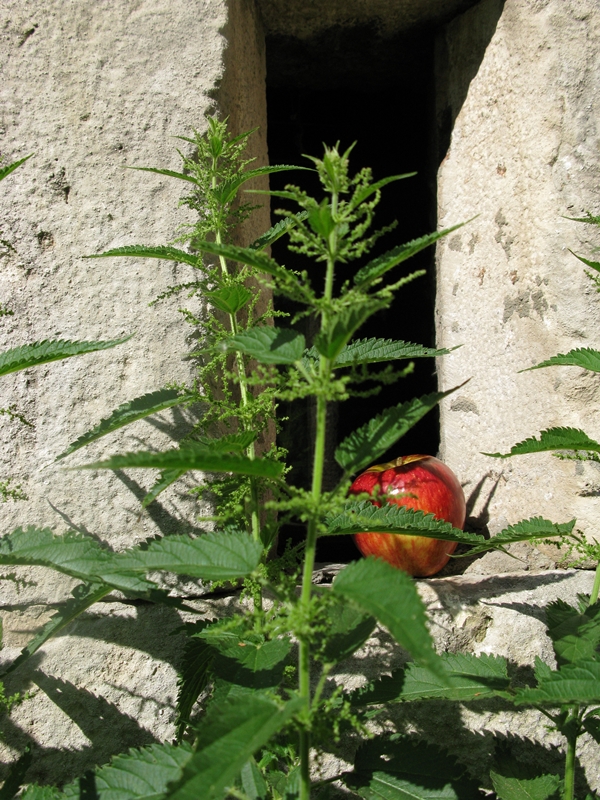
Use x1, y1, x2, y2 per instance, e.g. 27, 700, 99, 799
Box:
350, 455, 466, 578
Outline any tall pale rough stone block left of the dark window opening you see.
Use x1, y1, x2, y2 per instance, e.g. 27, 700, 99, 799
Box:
0, 0, 268, 576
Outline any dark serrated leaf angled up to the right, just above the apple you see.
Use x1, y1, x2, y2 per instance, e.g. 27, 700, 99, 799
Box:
335, 387, 458, 474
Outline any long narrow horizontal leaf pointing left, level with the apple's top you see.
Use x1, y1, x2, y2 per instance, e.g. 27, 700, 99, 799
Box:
75, 443, 283, 478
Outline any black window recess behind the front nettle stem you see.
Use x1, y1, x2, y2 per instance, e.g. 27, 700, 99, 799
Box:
267, 27, 439, 562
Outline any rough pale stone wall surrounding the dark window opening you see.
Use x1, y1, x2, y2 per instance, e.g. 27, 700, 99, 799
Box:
0, 0, 600, 788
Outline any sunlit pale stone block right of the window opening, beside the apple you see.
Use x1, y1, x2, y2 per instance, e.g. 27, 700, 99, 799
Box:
436, 0, 600, 552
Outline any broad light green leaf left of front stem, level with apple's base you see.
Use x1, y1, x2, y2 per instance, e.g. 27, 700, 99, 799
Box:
114, 531, 262, 581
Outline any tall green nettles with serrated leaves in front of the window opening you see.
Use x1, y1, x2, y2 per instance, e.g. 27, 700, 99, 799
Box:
0, 119, 600, 800
